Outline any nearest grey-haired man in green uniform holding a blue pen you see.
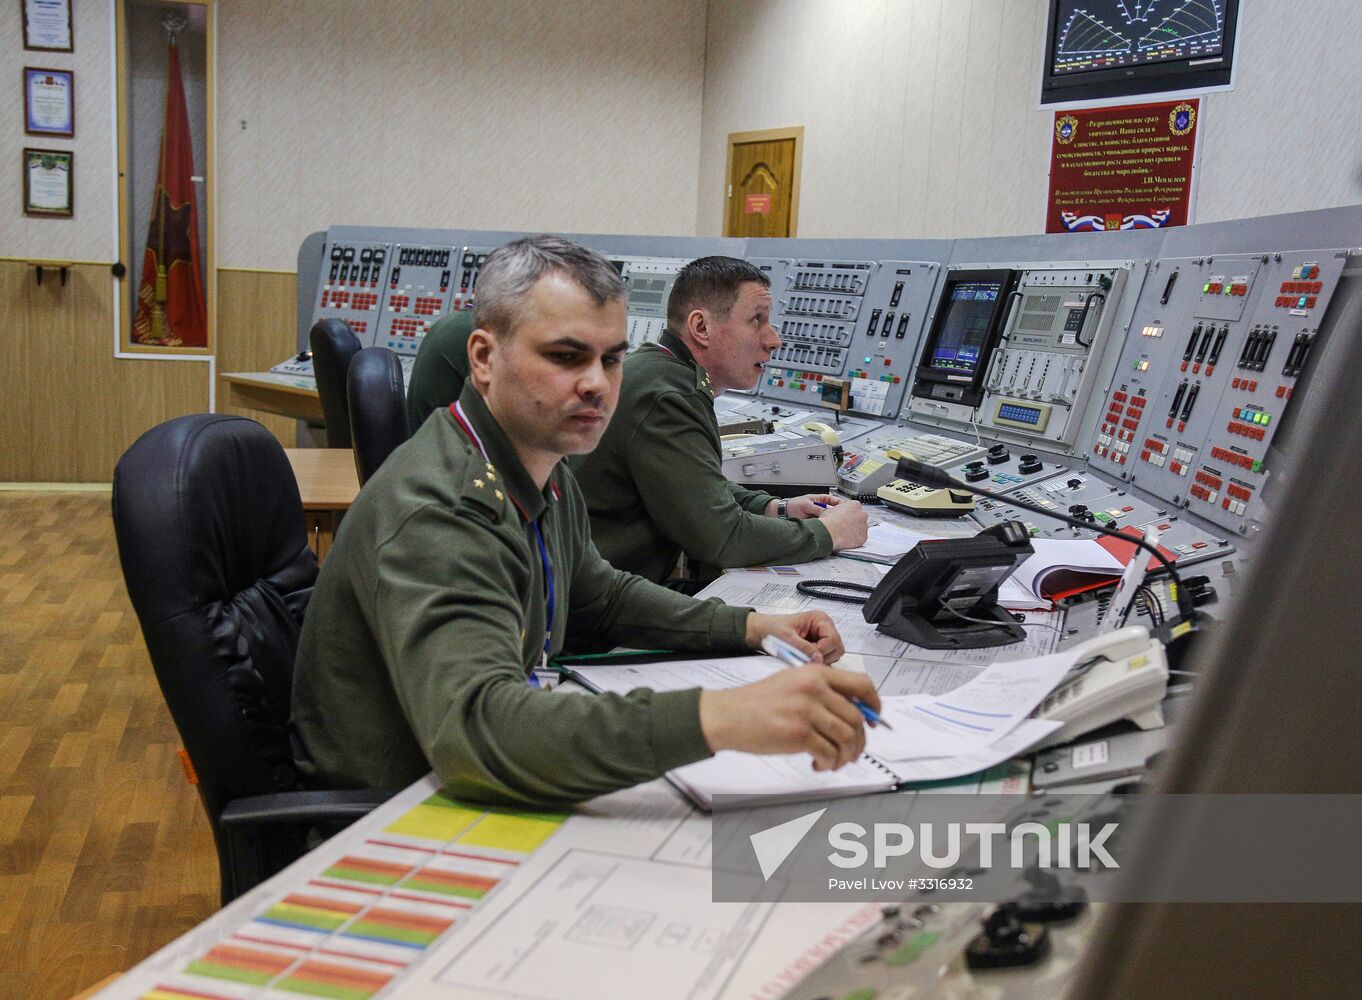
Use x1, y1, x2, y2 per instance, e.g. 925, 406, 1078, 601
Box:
291, 237, 878, 805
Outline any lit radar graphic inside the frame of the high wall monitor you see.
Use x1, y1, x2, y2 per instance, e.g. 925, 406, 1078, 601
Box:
1053, 0, 1224, 75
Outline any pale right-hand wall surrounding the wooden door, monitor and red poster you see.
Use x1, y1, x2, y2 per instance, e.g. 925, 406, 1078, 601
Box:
697, 0, 1362, 237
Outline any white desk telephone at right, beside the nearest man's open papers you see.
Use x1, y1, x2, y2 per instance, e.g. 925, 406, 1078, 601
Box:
1035, 625, 1169, 748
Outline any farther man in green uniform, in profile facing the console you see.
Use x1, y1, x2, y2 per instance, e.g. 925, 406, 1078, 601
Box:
572, 257, 866, 582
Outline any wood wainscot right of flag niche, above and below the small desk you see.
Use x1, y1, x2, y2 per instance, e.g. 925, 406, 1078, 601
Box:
217, 268, 298, 448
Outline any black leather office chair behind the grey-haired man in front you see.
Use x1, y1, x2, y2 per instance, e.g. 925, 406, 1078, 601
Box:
113, 414, 387, 903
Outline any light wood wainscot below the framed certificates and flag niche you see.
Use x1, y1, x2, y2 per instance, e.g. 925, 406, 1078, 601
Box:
0, 260, 208, 482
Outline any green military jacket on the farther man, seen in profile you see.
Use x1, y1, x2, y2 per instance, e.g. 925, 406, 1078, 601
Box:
569, 330, 832, 582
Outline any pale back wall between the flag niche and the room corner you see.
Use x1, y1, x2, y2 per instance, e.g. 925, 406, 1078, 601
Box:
217, 0, 706, 270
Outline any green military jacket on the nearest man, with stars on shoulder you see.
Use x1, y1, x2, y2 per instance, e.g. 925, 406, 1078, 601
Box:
291, 381, 749, 805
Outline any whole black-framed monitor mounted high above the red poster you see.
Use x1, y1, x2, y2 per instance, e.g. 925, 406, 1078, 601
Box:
1041, 0, 1239, 104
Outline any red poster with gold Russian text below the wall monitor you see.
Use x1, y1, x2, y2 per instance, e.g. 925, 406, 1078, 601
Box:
1045, 98, 1201, 233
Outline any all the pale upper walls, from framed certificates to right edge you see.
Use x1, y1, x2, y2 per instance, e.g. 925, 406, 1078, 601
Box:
0, 0, 1362, 270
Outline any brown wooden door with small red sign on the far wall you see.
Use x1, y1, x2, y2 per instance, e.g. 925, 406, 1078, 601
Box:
723, 127, 804, 237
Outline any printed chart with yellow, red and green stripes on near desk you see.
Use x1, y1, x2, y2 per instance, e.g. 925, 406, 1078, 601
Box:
140, 792, 567, 1000
